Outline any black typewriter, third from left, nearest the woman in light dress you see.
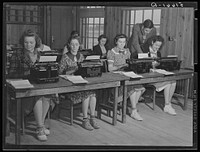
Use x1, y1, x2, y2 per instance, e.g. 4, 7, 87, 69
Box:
125, 58, 154, 73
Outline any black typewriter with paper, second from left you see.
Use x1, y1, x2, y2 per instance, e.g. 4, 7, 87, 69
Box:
74, 55, 103, 77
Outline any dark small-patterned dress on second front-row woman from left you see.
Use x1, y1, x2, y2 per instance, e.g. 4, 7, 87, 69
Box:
59, 52, 96, 104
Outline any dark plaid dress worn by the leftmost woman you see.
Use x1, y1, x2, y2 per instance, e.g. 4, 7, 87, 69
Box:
9, 49, 59, 114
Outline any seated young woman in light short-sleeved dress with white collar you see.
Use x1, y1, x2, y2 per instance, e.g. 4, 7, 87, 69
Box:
107, 34, 145, 121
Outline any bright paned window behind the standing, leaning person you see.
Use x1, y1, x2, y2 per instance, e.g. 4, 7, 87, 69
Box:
122, 8, 161, 37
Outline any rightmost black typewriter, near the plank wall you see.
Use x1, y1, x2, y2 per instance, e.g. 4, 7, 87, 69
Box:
156, 57, 182, 71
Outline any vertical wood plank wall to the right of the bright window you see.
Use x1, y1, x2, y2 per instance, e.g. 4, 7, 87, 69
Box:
160, 8, 194, 69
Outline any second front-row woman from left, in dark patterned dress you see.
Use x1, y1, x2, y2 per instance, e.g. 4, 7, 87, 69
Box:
59, 36, 100, 130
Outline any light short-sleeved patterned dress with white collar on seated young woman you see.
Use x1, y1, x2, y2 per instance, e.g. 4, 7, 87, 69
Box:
107, 47, 145, 99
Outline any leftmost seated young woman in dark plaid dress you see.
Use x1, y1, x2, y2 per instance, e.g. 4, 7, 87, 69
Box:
10, 30, 57, 141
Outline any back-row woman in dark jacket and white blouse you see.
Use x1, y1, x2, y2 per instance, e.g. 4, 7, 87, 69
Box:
93, 34, 108, 58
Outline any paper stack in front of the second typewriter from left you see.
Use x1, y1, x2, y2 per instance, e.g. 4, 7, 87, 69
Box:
60, 75, 88, 84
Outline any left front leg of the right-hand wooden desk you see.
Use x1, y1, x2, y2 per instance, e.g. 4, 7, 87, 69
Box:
122, 83, 127, 123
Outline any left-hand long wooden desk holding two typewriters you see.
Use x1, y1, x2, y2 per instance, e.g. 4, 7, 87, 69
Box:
7, 73, 127, 145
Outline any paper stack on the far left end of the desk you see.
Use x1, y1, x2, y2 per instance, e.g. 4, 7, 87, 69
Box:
6, 80, 34, 89
